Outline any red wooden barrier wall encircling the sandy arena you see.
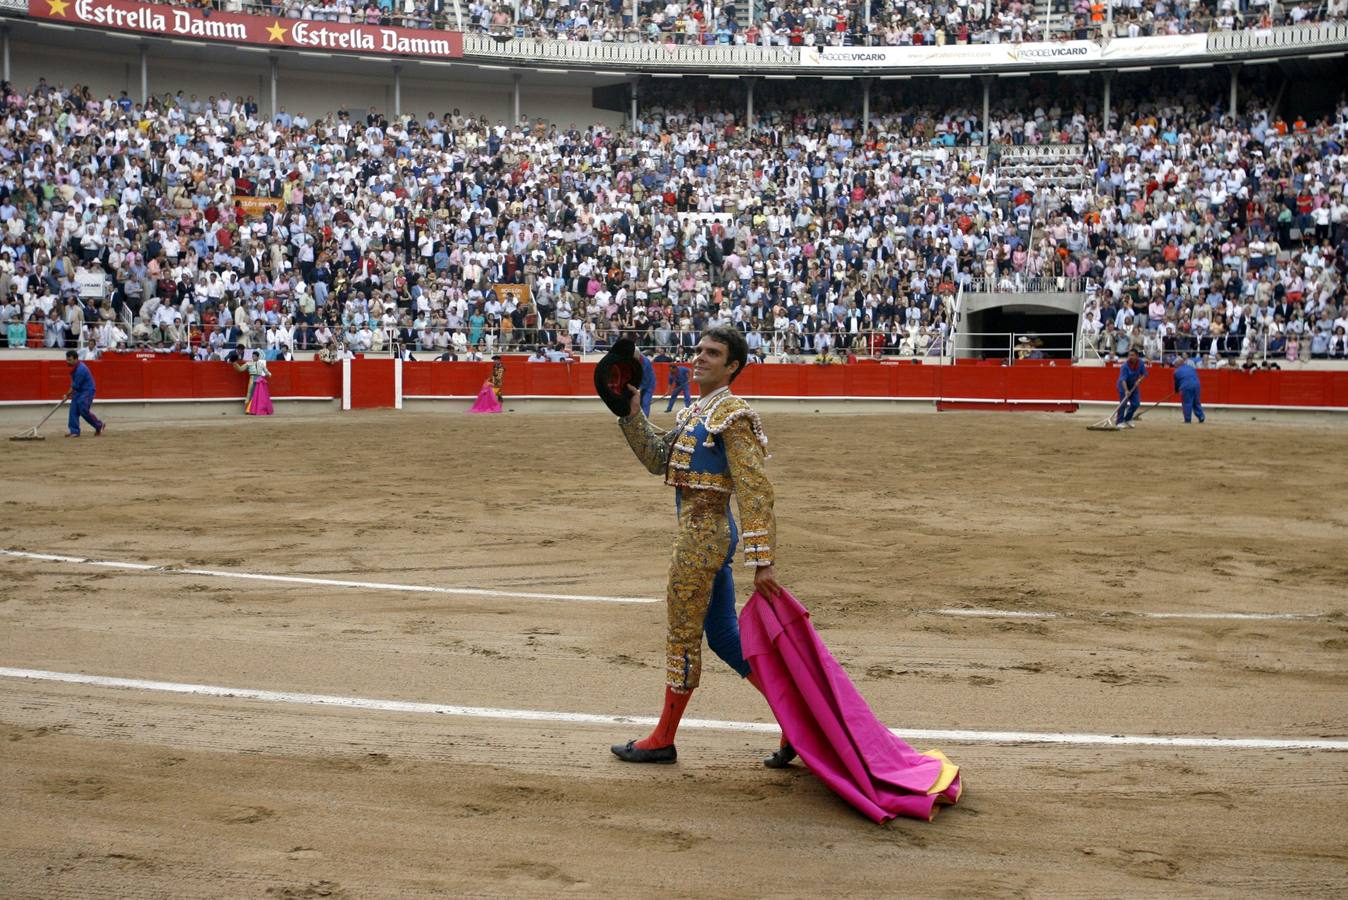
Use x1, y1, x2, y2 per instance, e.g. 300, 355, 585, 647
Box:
0, 357, 1348, 410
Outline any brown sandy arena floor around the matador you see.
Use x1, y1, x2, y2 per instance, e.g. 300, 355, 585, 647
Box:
0, 404, 1348, 897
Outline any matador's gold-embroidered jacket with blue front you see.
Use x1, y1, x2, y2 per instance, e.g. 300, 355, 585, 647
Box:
617, 388, 776, 566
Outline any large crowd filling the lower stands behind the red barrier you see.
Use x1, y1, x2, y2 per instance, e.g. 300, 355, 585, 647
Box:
0, 67, 1348, 362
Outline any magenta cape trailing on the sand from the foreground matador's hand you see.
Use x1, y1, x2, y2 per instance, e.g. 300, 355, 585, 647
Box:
740, 591, 961, 822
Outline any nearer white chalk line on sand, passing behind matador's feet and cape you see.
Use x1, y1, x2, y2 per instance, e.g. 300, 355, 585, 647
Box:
0, 667, 1348, 750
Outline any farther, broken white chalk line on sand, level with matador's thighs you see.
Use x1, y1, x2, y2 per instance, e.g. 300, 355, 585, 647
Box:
0, 548, 1329, 621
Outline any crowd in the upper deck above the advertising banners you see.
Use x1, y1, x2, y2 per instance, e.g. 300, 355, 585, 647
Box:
147, 0, 1348, 46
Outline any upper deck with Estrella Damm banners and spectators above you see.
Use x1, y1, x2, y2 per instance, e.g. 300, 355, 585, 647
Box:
0, 0, 1348, 79
